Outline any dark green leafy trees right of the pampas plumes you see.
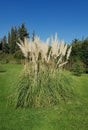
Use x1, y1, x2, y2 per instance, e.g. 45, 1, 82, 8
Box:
69, 38, 88, 73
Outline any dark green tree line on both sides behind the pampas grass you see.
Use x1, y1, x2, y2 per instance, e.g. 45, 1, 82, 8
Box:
0, 23, 88, 73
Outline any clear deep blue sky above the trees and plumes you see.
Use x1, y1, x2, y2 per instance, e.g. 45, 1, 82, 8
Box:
0, 0, 88, 43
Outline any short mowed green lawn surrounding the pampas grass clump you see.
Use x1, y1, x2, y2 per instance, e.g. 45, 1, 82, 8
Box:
0, 64, 88, 130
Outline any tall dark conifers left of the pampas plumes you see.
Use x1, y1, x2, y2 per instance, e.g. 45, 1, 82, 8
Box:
0, 23, 29, 54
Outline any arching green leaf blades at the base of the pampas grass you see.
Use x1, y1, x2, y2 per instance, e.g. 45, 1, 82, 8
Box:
15, 66, 73, 108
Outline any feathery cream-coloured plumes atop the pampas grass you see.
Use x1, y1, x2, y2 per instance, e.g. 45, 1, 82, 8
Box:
17, 33, 72, 67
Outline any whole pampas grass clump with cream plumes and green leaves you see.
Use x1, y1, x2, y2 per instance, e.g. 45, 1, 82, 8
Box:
16, 34, 72, 108
